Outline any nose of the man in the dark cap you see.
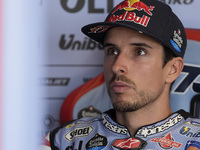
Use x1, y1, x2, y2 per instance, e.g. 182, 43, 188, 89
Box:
112, 53, 128, 75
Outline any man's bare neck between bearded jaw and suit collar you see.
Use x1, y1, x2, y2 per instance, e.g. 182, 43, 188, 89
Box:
116, 88, 172, 136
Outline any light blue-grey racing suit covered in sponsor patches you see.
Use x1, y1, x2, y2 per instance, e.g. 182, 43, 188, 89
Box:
43, 110, 200, 150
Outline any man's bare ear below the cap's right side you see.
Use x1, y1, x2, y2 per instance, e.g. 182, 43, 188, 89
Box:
166, 57, 184, 83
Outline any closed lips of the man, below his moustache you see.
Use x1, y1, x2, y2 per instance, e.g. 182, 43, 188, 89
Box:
110, 82, 131, 93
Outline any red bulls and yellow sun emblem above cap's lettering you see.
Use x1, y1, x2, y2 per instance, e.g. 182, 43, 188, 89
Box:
112, 0, 155, 16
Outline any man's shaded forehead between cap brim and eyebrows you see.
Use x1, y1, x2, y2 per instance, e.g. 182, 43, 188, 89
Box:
104, 27, 162, 47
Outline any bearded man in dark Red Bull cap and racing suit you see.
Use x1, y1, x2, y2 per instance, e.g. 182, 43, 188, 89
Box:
41, 0, 200, 150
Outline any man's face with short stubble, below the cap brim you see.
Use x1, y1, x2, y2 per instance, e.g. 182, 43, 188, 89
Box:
104, 27, 167, 112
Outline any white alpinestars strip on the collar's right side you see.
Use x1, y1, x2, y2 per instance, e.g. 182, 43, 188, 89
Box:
137, 114, 183, 137
